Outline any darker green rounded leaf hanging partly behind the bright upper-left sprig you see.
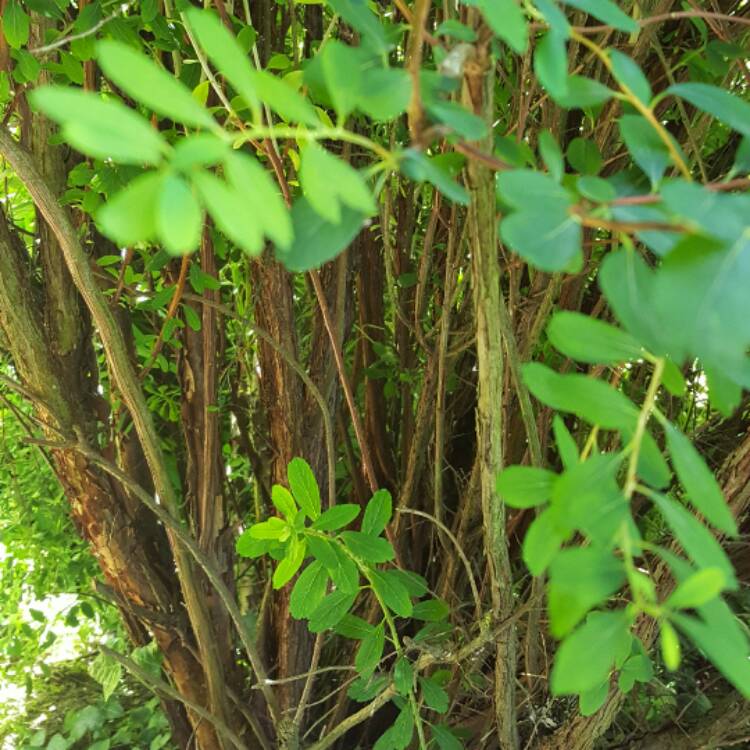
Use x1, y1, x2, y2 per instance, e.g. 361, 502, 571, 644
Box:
276, 198, 367, 272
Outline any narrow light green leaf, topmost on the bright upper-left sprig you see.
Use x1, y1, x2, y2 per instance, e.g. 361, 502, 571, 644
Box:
187, 8, 258, 116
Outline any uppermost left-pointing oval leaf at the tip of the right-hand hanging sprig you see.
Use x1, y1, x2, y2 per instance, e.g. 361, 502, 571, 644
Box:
547, 312, 643, 365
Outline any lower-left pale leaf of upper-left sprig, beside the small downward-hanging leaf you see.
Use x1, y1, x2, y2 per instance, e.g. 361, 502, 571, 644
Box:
96, 172, 162, 247
